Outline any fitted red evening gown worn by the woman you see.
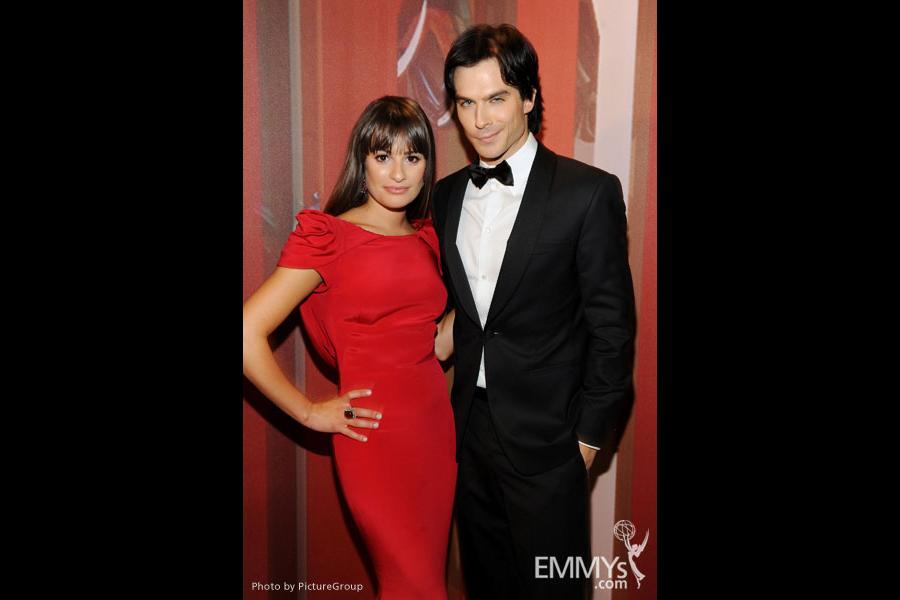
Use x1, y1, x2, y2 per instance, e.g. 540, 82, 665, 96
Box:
278, 210, 456, 600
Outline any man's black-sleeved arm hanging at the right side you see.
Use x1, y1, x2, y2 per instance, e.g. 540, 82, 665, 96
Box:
576, 175, 635, 454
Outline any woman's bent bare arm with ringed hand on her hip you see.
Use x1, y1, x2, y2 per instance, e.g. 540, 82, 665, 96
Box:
244, 267, 381, 442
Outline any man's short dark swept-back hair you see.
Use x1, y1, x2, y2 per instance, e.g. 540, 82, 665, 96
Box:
444, 23, 544, 134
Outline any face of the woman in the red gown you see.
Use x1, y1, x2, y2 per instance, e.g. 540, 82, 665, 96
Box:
366, 139, 425, 210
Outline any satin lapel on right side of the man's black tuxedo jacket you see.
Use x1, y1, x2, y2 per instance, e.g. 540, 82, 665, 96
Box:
486, 144, 556, 327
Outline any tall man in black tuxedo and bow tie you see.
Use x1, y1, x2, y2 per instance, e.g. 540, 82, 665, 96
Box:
433, 25, 634, 600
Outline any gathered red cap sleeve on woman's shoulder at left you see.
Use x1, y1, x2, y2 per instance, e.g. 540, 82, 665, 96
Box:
278, 209, 342, 292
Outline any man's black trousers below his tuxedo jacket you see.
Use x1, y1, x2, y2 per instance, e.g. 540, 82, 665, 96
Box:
456, 388, 591, 600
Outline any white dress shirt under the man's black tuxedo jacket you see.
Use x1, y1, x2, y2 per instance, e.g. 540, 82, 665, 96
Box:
456, 131, 597, 449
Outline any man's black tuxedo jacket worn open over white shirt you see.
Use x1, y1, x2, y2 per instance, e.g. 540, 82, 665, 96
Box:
433, 144, 634, 475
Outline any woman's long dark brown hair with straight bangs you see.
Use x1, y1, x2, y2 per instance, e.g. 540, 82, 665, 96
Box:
324, 96, 435, 220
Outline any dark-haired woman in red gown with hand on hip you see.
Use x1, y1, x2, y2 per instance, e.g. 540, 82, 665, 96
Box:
244, 96, 456, 600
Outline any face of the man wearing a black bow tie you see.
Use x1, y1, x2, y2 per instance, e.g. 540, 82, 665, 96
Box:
453, 58, 534, 165
